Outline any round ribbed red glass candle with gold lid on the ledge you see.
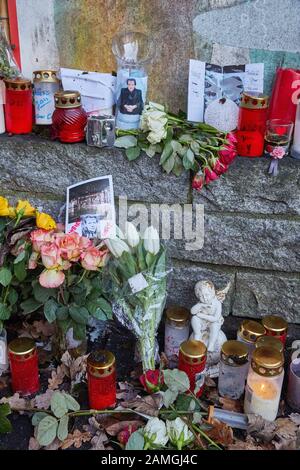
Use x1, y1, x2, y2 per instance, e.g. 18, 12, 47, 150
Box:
52, 90, 87, 143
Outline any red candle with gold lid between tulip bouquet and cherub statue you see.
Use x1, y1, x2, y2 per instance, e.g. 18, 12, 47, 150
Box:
178, 339, 207, 397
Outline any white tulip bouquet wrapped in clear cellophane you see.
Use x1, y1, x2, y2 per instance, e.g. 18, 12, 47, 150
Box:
105, 224, 170, 372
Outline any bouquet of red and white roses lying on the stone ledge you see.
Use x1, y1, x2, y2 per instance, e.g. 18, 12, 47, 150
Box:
115, 102, 237, 191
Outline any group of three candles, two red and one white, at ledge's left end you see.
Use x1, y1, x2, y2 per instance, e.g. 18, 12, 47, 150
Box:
0, 70, 87, 143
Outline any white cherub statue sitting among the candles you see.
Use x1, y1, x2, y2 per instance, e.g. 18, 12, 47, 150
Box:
191, 281, 230, 362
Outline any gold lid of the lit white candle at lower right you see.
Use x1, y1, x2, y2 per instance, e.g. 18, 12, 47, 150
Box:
251, 346, 284, 377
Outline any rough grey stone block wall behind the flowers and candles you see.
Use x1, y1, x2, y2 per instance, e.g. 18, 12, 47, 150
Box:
0, 132, 300, 323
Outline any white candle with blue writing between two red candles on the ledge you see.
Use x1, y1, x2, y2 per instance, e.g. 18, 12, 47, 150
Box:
33, 70, 60, 125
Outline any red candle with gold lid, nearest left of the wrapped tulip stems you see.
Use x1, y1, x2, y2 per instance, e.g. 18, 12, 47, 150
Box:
87, 350, 117, 410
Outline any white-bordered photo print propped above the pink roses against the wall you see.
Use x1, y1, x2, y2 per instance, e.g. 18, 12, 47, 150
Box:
66, 175, 116, 239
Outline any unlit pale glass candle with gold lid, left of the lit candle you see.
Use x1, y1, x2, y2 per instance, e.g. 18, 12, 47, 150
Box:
218, 340, 248, 400
